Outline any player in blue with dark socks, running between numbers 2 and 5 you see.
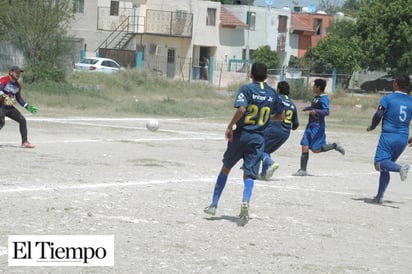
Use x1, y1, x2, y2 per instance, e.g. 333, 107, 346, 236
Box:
293, 79, 345, 176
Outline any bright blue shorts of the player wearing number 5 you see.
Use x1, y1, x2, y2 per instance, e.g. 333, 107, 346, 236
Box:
374, 133, 408, 164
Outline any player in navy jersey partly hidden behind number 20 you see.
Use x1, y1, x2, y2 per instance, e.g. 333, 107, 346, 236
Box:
259, 81, 299, 180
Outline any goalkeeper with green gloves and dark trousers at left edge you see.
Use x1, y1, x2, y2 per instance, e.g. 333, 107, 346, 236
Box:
0, 66, 38, 148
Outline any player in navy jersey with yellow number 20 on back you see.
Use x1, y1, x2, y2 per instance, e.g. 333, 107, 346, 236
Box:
204, 62, 284, 226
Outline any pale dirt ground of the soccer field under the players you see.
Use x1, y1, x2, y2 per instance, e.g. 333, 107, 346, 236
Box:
0, 116, 412, 273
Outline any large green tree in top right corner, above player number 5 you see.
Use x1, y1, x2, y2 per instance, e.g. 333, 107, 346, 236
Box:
356, 0, 412, 72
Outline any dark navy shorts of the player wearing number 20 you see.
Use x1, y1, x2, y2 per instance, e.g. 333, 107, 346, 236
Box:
222, 131, 264, 179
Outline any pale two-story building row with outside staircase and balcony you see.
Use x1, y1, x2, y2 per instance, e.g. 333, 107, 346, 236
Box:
71, 0, 291, 78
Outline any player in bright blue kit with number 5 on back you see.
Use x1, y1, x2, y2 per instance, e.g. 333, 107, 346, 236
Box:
366, 74, 412, 204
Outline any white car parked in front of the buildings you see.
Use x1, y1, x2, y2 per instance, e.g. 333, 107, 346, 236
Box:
74, 57, 121, 73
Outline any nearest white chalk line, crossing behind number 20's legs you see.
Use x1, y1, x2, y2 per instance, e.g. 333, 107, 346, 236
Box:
0, 173, 372, 195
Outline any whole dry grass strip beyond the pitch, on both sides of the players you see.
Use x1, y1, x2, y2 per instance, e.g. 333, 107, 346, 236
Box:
23, 70, 382, 131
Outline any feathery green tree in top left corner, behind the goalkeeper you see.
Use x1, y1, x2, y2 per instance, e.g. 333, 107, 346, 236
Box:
0, 0, 73, 82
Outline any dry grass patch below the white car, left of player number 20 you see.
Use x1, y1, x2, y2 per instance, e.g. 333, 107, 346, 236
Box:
23, 70, 233, 117
